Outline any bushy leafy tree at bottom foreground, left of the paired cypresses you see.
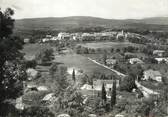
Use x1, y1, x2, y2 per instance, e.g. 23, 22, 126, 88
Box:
54, 85, 84, 117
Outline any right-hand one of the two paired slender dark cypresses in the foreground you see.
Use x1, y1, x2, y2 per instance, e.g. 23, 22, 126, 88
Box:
111, 80, 116, 107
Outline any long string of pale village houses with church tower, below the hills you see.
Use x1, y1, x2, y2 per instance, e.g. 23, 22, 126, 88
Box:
27, 31, 143, 43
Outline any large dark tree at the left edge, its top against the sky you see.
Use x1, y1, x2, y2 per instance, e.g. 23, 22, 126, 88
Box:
0, 8, 26, 115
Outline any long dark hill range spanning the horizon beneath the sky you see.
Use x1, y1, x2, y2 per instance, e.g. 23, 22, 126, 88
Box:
15, 16, 168, 35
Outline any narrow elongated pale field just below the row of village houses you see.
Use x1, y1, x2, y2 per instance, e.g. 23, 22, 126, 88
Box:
79, 42, 143, 49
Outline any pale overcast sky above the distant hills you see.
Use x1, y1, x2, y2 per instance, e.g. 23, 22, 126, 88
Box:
0, 0, 168, 19
